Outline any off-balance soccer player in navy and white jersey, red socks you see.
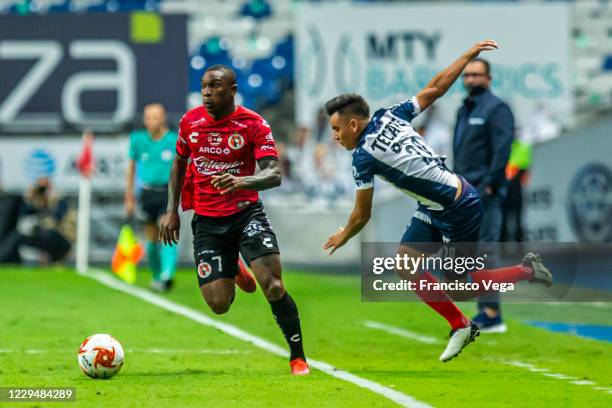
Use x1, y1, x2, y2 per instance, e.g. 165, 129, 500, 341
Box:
324, 40, 552, 362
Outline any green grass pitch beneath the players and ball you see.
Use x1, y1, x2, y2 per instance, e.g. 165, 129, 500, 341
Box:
0, 268, 612, 408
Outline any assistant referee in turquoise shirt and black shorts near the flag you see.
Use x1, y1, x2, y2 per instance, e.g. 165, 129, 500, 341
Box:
125, 103, 178, 292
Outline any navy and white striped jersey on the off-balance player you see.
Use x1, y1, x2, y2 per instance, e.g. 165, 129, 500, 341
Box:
353, 97, 459, 210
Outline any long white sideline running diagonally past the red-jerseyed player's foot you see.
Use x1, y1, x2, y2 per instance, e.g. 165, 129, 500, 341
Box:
84, 270, 430, 408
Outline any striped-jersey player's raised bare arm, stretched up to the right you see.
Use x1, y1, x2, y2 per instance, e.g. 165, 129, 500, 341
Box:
416, 40, 499, 112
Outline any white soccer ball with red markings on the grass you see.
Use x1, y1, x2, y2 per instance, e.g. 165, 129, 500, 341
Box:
79, 334, 125, 379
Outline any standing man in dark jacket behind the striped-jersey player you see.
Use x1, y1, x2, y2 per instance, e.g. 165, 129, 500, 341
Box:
453, 58, 514, 332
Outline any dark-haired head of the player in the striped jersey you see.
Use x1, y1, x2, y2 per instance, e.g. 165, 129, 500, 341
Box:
325, 93, 370, 150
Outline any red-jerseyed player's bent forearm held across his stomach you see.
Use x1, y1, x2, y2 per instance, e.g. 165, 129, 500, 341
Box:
212, 157, 282, 194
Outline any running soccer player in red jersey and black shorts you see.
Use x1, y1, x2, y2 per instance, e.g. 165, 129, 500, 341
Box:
160, 65, 309, 375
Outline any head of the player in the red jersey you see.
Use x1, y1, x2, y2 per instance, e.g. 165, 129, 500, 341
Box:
202, 65, 238, 118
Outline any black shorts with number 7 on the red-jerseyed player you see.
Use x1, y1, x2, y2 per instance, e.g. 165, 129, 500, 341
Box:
191, 201, 279, 286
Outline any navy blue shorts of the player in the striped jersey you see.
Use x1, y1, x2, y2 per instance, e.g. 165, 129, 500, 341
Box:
401, 177, 483, 252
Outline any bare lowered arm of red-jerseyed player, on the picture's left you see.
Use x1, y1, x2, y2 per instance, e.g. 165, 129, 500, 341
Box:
159, 154, 189, 245
